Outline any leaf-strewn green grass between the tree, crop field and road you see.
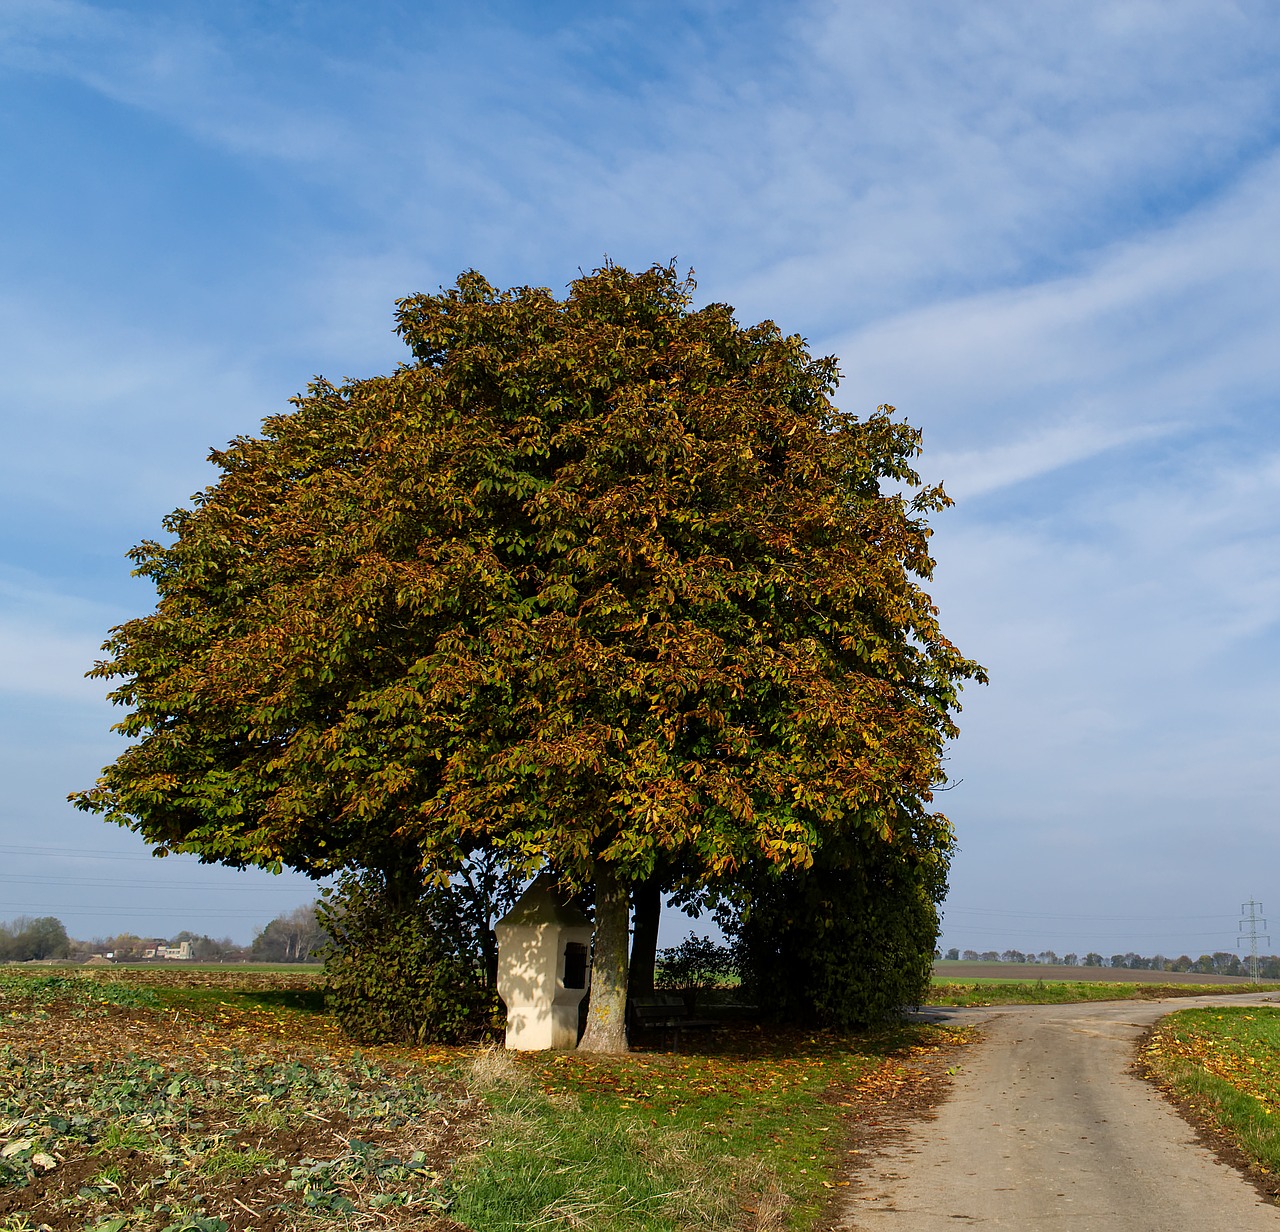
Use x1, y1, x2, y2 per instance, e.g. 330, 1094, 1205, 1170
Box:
449, 1027, 959, 1232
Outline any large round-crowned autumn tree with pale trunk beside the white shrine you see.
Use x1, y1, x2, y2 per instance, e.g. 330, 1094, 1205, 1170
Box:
73, 258, 982, 1049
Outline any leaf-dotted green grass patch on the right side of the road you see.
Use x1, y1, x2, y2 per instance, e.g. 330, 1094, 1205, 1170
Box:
1142, 1005, 1280, 1173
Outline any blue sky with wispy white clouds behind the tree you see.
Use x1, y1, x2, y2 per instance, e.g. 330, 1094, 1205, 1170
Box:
0, 0, 1280, 957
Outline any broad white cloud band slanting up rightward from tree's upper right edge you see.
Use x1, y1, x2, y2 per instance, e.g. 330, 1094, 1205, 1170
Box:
833, 144, 1280, 494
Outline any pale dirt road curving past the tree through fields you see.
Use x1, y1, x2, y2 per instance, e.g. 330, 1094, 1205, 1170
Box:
842, 993, 1280, 1232
